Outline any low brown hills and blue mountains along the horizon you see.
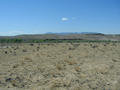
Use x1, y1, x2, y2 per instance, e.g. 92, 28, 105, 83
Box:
0, 32, 120, 41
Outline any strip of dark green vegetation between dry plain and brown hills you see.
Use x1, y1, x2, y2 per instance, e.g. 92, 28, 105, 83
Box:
0, 38, 120, 43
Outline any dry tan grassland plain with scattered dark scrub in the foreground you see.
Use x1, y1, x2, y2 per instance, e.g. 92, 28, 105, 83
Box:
0, 43, 120, 90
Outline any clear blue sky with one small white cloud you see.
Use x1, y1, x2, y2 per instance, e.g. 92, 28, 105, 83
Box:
0, 0, 120, 36
